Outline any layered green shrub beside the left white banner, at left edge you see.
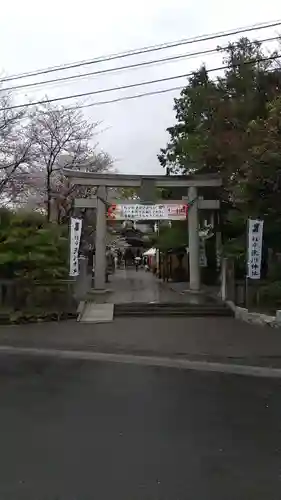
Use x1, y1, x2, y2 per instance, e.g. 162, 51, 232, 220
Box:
0, 210, 68, 282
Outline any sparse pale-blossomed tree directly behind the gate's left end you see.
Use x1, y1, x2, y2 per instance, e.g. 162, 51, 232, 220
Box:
23, 102, 113, 220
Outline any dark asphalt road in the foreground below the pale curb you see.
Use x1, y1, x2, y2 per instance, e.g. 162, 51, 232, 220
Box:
0, 355, 281, 500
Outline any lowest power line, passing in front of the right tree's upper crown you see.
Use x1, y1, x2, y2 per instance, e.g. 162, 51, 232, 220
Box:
2, 55, 281, 111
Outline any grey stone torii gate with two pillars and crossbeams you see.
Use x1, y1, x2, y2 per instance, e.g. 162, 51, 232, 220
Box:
63, 169, 222, 292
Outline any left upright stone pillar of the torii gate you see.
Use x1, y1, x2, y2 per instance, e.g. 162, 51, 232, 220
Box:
94, 186, 106, 290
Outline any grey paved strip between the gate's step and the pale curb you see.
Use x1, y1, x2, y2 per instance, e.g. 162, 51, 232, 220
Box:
0, 317, 281, 367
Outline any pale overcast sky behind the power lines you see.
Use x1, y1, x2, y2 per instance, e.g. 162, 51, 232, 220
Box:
0, 0, 281, 174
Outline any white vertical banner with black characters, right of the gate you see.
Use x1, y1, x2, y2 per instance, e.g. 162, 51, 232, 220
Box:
248, 219, 263, 280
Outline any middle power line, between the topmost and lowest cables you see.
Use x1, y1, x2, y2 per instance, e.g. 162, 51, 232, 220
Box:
0, 36, 280, 92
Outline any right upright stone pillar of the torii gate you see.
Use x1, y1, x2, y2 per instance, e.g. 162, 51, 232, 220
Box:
188, 186, 200, 292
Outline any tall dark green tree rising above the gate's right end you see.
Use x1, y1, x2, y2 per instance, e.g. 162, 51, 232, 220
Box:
159, 38, 281, 186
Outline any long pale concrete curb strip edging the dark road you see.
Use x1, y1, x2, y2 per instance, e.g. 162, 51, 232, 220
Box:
0, 346, 281, 378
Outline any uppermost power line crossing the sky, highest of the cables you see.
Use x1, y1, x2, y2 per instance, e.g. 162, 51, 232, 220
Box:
0, 20, 281, 83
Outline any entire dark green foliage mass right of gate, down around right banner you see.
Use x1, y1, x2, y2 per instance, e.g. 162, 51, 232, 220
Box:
158, 38, 281, 262
